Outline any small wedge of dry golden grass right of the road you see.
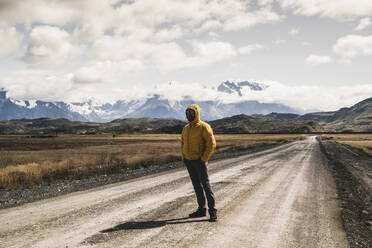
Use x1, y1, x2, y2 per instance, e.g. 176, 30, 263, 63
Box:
322, 134, 372, 156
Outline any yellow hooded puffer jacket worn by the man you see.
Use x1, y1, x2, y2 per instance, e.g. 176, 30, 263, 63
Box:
181, 104, 216, 162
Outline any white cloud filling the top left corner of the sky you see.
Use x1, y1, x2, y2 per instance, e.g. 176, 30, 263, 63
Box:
0, 0, 118, 38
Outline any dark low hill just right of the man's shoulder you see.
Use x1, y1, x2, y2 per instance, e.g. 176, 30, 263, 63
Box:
209, 115, 324, 133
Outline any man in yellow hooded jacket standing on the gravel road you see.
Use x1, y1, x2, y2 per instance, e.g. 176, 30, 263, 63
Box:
181, 104, 217, 221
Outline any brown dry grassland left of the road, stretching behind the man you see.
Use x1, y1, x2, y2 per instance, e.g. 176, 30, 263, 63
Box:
0, 134, 306, 189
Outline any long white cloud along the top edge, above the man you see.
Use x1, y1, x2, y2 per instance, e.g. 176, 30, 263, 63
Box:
112, 0, 281, 34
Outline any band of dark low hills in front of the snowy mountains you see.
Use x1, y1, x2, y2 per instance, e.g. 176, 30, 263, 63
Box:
0, 98, 372, 135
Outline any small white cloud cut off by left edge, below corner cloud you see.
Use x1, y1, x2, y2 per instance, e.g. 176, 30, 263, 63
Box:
0, 27, 23, 58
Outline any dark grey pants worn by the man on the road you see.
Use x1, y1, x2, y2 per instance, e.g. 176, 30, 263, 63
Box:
184, 159, 216, 211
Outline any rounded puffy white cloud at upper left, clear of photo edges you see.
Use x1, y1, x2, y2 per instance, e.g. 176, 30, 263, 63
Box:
23, 26, 82, 63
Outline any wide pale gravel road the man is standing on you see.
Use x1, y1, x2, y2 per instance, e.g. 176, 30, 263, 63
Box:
0, 137, 348, 248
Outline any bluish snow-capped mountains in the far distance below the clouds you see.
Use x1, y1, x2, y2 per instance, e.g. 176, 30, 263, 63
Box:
0, 81, 298, 122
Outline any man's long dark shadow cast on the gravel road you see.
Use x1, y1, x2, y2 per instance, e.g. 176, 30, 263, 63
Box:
101, 217, 209, 233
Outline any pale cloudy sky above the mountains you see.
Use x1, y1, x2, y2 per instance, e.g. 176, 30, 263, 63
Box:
0, 0, 372, 111
